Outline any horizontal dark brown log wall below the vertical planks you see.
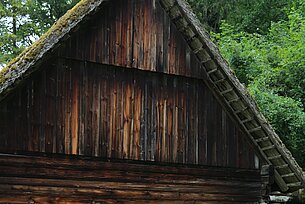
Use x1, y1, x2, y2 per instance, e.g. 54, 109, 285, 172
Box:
0, 154, 262, 203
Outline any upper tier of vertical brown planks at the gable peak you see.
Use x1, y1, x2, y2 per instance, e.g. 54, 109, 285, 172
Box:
58, 0, 203, 78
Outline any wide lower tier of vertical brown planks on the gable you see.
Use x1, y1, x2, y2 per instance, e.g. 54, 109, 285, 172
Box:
0, 59, 255, 168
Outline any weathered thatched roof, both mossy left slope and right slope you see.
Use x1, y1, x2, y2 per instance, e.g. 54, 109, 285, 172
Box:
0, 0, 305, 192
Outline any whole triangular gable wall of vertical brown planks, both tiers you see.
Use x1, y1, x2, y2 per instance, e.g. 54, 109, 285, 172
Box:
0, 0, 259, 169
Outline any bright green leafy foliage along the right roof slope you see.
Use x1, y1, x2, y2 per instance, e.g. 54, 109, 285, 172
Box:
213, 3, 305, 168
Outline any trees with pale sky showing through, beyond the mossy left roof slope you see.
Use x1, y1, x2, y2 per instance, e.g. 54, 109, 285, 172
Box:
0, 0, 79, 67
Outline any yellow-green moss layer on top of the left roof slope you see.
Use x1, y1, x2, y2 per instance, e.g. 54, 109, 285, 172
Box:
0, 0, 102, 86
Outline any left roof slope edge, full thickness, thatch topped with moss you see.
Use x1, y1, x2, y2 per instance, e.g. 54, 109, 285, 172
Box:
0, 0, 104, 95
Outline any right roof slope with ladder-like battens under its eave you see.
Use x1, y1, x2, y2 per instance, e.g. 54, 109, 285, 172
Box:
160, 0, 305, 192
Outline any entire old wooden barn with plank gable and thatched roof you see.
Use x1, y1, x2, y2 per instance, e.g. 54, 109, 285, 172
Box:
0, 0, 304, 203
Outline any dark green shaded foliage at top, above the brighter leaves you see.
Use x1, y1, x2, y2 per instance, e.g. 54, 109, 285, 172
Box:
188, 0, 295, 34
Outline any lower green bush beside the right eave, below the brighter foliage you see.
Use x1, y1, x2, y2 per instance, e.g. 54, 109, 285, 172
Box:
248, 81, 305, 168
